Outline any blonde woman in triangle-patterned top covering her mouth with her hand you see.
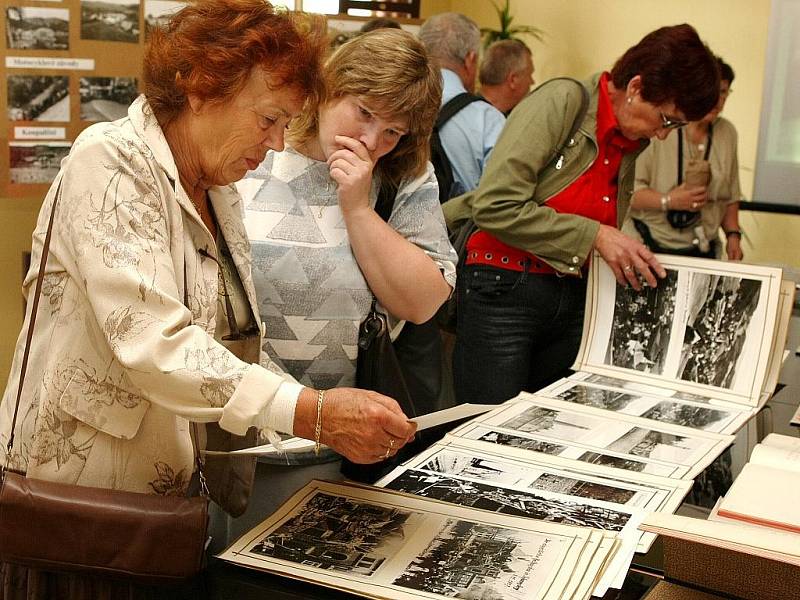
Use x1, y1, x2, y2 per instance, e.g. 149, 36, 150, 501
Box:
237, 29, 457, 476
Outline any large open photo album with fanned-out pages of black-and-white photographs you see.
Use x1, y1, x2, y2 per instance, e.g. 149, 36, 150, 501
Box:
221, 256, 794, 599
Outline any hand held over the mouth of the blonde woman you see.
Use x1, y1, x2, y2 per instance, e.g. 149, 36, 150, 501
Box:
327, 135, 375, 215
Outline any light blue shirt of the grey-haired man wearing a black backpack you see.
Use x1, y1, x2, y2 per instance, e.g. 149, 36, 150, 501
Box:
439, 69, 506, 195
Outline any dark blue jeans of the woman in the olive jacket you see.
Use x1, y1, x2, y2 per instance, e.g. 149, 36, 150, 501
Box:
453, 265, 586, 404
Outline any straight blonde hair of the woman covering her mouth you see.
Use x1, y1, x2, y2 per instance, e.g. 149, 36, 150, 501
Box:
288, 29, 442, 183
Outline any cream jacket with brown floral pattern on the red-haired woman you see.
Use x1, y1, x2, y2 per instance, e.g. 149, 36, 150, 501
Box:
0, 96, 294, 494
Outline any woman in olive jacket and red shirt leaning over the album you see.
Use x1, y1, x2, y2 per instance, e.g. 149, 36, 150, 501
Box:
443, 25, 719, 403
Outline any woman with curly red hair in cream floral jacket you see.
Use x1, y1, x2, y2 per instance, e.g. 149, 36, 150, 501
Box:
0, 0, 414, 597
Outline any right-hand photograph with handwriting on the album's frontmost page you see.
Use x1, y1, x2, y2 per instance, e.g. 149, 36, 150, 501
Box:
393, 519, 559, 600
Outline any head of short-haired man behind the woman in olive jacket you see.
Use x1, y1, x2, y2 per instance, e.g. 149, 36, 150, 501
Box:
478, 40, 536, 116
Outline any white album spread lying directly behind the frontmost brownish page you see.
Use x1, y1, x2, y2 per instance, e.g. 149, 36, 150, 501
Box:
376, 436, 691, 596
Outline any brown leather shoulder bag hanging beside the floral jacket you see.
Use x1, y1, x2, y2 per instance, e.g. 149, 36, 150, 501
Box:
0, 176, 208, 584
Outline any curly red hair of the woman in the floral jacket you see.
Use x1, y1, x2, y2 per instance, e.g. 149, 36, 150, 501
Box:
143, 0, 327, 127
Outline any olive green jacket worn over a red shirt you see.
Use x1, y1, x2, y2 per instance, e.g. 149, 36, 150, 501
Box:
442, 74, 648, 275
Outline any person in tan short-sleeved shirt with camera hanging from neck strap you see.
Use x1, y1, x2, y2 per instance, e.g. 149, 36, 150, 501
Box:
622, 58, 744, 260
